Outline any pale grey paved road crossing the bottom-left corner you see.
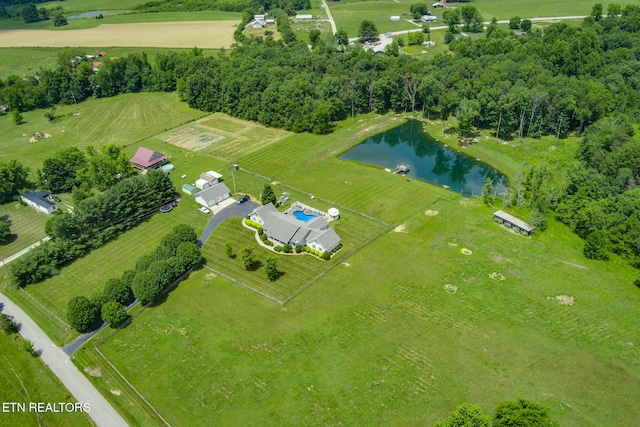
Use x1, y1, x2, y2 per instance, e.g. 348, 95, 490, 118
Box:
0, 293, 127, 427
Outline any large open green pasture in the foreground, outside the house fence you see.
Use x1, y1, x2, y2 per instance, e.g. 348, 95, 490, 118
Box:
92, 192, 640, 426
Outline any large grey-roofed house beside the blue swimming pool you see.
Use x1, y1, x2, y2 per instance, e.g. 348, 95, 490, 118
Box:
249, 203, 340, 252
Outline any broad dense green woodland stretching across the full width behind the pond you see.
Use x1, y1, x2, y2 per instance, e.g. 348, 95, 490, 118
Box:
0, 5, 640, 138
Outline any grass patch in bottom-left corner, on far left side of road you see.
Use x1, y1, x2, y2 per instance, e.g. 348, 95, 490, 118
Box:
0, 332, 93, 427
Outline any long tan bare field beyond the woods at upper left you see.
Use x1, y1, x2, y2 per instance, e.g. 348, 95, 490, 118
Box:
0, 21, 240, 49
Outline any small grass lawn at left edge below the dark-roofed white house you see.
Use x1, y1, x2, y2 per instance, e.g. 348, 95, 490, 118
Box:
0, 202, 48, 260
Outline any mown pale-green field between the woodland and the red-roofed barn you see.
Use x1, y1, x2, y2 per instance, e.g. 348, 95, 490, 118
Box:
0, 93, 204, 171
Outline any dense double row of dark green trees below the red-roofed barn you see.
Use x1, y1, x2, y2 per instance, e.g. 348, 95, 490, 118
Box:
10, 170, 178, 286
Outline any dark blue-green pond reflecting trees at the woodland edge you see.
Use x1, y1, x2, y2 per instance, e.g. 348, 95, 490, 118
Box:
339, 120, 509, 197
